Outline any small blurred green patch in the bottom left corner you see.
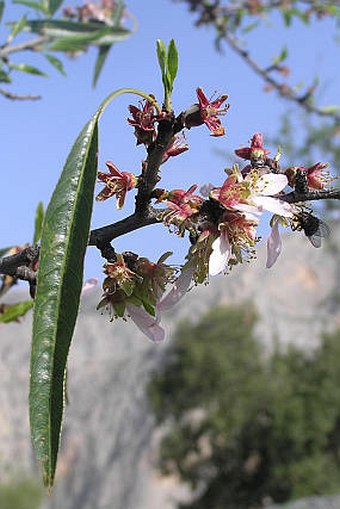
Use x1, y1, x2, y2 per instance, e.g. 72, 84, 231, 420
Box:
0, 478, 43, 509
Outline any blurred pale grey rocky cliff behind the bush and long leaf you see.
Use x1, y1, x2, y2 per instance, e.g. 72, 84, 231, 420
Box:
0, 226, 340, 509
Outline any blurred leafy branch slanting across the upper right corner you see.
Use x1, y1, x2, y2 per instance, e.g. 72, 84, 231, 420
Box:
173, 0, 340, 125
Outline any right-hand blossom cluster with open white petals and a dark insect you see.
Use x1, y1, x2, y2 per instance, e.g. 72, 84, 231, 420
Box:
158, 133, 331, 283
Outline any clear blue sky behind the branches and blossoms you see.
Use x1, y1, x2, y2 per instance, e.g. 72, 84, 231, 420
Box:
0, 0, 340, 277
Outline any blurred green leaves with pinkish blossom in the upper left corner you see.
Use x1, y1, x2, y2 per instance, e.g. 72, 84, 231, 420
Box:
0, 0, 132, 96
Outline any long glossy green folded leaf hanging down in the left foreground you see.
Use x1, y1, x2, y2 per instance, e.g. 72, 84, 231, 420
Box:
30, 111, 100, 489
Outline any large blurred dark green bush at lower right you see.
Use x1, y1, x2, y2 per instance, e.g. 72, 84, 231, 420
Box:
149, 305, 340, 509
